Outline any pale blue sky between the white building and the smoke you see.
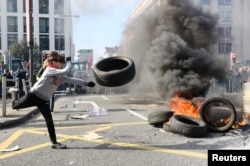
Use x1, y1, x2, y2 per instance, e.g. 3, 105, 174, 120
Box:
71, 0, 141, 63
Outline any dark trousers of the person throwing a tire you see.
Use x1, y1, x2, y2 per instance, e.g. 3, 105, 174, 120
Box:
12, 92, 57, 143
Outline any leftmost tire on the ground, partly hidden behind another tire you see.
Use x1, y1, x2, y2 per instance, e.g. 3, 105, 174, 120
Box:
148, 111, 174, 126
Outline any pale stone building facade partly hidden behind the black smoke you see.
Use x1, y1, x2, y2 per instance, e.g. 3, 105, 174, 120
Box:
128, 0, 250, 63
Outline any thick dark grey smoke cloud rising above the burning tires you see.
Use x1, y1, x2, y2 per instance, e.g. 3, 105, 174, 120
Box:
123, 0, 228, 99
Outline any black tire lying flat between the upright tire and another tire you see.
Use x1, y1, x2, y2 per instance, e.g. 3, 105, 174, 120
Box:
169, 115, 207, 138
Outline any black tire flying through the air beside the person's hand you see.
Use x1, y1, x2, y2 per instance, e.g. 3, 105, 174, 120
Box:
93, 56, 135, 87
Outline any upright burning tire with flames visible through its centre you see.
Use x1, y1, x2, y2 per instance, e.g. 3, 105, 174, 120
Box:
199, 97, 236, 132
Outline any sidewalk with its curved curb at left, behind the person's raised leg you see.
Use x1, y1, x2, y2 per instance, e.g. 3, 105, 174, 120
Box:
0, 98, 39, 130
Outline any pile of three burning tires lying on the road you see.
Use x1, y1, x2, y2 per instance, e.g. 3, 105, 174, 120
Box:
148, 97, 236, 137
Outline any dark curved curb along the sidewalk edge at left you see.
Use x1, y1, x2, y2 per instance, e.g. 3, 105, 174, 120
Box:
0, 108, 40, 130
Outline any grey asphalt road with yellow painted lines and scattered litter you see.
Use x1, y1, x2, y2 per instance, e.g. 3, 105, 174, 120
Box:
0, 95, 250, 166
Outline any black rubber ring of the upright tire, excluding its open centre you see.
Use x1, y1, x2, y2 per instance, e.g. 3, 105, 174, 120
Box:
199, 97, 237, 132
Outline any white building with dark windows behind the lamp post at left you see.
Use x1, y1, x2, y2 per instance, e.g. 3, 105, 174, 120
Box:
0, 0, 77, 57
